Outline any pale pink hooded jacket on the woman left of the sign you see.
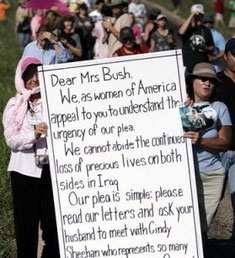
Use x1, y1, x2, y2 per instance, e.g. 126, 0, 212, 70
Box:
3, 57, 46, 178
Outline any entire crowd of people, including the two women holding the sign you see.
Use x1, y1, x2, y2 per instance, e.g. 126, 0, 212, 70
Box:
3, 0, 235, 258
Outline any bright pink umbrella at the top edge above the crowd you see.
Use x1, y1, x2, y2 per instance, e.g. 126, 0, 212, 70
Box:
24, 0, 73, 15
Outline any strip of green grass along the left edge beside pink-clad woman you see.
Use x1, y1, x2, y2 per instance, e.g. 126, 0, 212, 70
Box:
0, 0, 20, 258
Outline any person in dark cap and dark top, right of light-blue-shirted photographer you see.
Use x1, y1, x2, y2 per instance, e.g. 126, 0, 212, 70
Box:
58, 17, 82, 62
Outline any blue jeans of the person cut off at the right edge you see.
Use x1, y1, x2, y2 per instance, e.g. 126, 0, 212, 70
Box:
222, 150, 235, 235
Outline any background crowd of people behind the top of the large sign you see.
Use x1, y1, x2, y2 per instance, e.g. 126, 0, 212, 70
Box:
10, 0, 233, 72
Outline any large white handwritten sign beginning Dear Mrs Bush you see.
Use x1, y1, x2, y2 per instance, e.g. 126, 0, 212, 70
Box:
39, 50, 203, 258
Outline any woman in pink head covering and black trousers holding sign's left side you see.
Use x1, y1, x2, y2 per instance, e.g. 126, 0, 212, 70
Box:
3, 57, 59, 258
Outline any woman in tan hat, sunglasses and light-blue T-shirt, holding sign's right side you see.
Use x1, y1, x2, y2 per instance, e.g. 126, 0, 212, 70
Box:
180, 63, 231, 240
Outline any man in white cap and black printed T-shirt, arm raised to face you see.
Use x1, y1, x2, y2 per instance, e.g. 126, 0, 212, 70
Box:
178, 4, 214, 72
